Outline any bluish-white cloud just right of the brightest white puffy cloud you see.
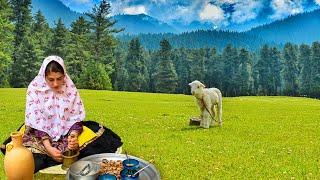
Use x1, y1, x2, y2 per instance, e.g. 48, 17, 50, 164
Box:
231, 0, 263, 24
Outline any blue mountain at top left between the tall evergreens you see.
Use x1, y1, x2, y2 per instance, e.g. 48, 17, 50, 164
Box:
32, 0, 82, 27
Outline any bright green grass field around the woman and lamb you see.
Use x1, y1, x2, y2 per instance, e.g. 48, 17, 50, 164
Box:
0, 89, 320, 179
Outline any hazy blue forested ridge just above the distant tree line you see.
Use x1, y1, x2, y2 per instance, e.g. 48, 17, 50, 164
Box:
117, 30, 268, 52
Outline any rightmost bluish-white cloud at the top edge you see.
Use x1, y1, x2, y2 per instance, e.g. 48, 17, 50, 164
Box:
269, 0, 303, 19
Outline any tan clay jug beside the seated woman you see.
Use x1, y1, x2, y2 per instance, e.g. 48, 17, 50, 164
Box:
4, 132, 34, 180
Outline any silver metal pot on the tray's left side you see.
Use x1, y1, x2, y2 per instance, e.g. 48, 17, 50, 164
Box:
69, 161, 100, 180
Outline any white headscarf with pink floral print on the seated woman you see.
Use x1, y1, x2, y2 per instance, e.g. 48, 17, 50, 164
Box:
25, 56, 85, 141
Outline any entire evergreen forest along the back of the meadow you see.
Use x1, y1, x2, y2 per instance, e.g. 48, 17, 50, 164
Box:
0, 0, 320, 98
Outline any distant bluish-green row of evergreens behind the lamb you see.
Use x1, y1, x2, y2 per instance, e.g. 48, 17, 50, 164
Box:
114, 38, 320, 98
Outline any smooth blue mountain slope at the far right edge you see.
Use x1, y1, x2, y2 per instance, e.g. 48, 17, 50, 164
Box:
247, 9, 320, 44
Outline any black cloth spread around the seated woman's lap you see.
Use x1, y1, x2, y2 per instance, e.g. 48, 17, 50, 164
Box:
1, 121, 123, 173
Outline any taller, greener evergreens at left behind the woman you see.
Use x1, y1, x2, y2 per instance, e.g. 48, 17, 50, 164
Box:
0, 0, 118, 89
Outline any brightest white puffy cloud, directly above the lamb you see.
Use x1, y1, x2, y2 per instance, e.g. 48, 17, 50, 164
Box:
199, 3, 225, 24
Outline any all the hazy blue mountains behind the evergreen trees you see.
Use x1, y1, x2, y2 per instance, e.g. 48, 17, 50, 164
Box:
32, 0, 320, 49
